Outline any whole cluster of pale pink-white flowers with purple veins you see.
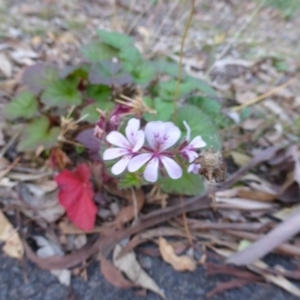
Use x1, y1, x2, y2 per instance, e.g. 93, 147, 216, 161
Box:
103, 118, 206, 182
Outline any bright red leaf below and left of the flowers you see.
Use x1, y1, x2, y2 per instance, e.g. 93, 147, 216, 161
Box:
55, 164, 97, 231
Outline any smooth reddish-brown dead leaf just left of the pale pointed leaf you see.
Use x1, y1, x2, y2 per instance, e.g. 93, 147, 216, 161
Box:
100, 255, 134, 289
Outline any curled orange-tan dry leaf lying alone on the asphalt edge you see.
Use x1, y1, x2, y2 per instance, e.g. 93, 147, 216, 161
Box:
159, 237, 197, 272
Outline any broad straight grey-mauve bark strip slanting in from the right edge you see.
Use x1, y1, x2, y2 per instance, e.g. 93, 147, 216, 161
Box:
227, 208, 300, 266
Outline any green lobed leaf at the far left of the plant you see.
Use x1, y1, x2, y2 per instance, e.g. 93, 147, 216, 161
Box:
17, 116, 60, 151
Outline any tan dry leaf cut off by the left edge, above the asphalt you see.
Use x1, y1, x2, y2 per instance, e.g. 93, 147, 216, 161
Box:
0, 210, 24, 259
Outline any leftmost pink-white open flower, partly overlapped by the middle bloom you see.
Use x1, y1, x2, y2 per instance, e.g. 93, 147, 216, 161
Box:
103, 118, 145, 175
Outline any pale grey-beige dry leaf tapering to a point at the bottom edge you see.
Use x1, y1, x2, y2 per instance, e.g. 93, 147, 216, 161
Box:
113, 244, 166, 299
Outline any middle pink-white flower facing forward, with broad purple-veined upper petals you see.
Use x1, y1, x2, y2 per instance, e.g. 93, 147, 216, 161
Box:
128, 121, 182, 182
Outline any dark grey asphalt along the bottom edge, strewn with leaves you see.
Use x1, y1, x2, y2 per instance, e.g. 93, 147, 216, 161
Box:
0, 254, 298, 300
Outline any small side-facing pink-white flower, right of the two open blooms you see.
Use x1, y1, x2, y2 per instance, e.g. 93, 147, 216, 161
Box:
179, 121, 206, 163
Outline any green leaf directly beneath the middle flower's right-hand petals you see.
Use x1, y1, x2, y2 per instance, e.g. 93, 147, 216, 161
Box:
158, 170, 204, 196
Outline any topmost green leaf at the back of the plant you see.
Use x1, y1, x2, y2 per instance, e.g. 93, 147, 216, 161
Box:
81, 41, 119, 62
